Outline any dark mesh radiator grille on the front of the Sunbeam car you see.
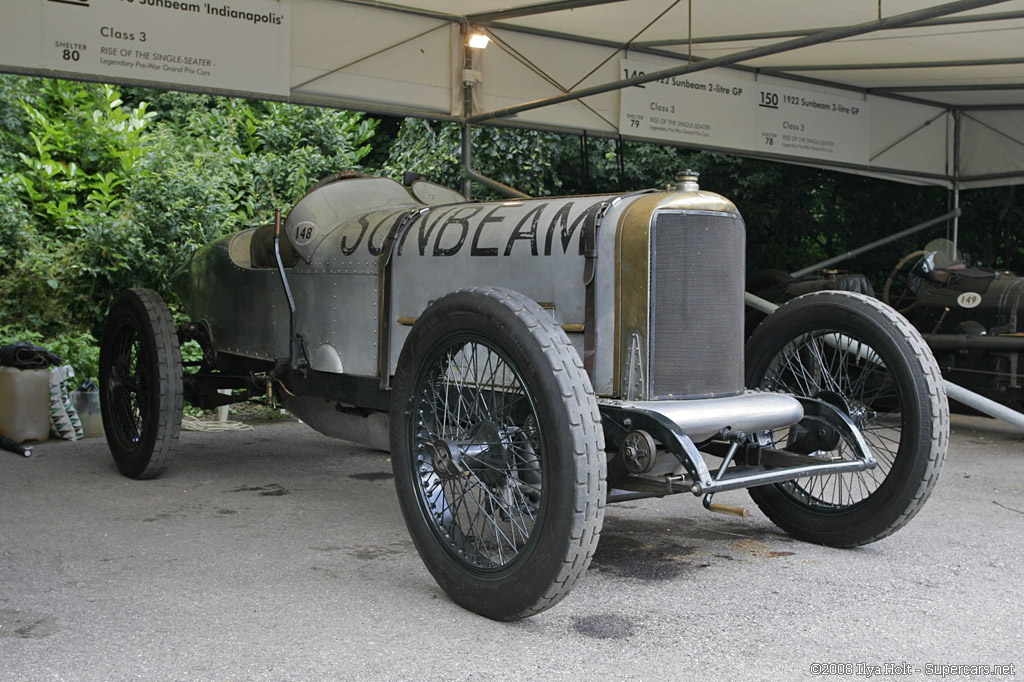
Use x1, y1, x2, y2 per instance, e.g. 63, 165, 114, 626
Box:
648, 206, 745, 399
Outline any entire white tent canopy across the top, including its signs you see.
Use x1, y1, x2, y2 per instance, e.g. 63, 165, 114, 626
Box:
0, 0, 1024, 187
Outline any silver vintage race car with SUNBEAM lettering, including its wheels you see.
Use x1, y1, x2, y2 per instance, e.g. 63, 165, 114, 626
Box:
100, 168, 948, 620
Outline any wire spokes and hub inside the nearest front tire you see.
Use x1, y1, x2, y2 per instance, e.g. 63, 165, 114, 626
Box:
414, 340, 547, 569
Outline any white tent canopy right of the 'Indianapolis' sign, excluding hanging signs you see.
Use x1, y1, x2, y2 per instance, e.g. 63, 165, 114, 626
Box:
292, 0, 1024, 186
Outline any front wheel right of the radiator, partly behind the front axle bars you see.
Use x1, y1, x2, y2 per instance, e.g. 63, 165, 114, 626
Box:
746, 291, 949, 547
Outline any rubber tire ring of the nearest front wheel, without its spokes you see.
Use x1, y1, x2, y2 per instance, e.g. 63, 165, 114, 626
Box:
391, 287, 607, 621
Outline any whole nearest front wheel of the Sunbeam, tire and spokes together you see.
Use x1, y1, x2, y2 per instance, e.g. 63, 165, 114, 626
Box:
391, 287, 607, 621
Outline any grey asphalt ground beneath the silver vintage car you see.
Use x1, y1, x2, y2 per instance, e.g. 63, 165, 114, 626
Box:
0, 417, 1024, 682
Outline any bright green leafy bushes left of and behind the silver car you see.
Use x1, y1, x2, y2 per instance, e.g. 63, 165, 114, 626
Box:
0, 76, 376, 376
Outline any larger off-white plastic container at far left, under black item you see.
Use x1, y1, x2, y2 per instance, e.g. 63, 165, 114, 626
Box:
0, 367, 50, 440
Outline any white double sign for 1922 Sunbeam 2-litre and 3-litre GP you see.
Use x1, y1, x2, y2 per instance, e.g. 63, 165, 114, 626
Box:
618, 59, 870, 165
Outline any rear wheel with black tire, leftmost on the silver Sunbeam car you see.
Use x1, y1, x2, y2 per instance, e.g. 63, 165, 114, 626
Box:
99, 289, 182, 478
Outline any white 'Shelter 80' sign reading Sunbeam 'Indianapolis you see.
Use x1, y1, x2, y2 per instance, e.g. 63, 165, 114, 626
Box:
0, 0, 291, 96
